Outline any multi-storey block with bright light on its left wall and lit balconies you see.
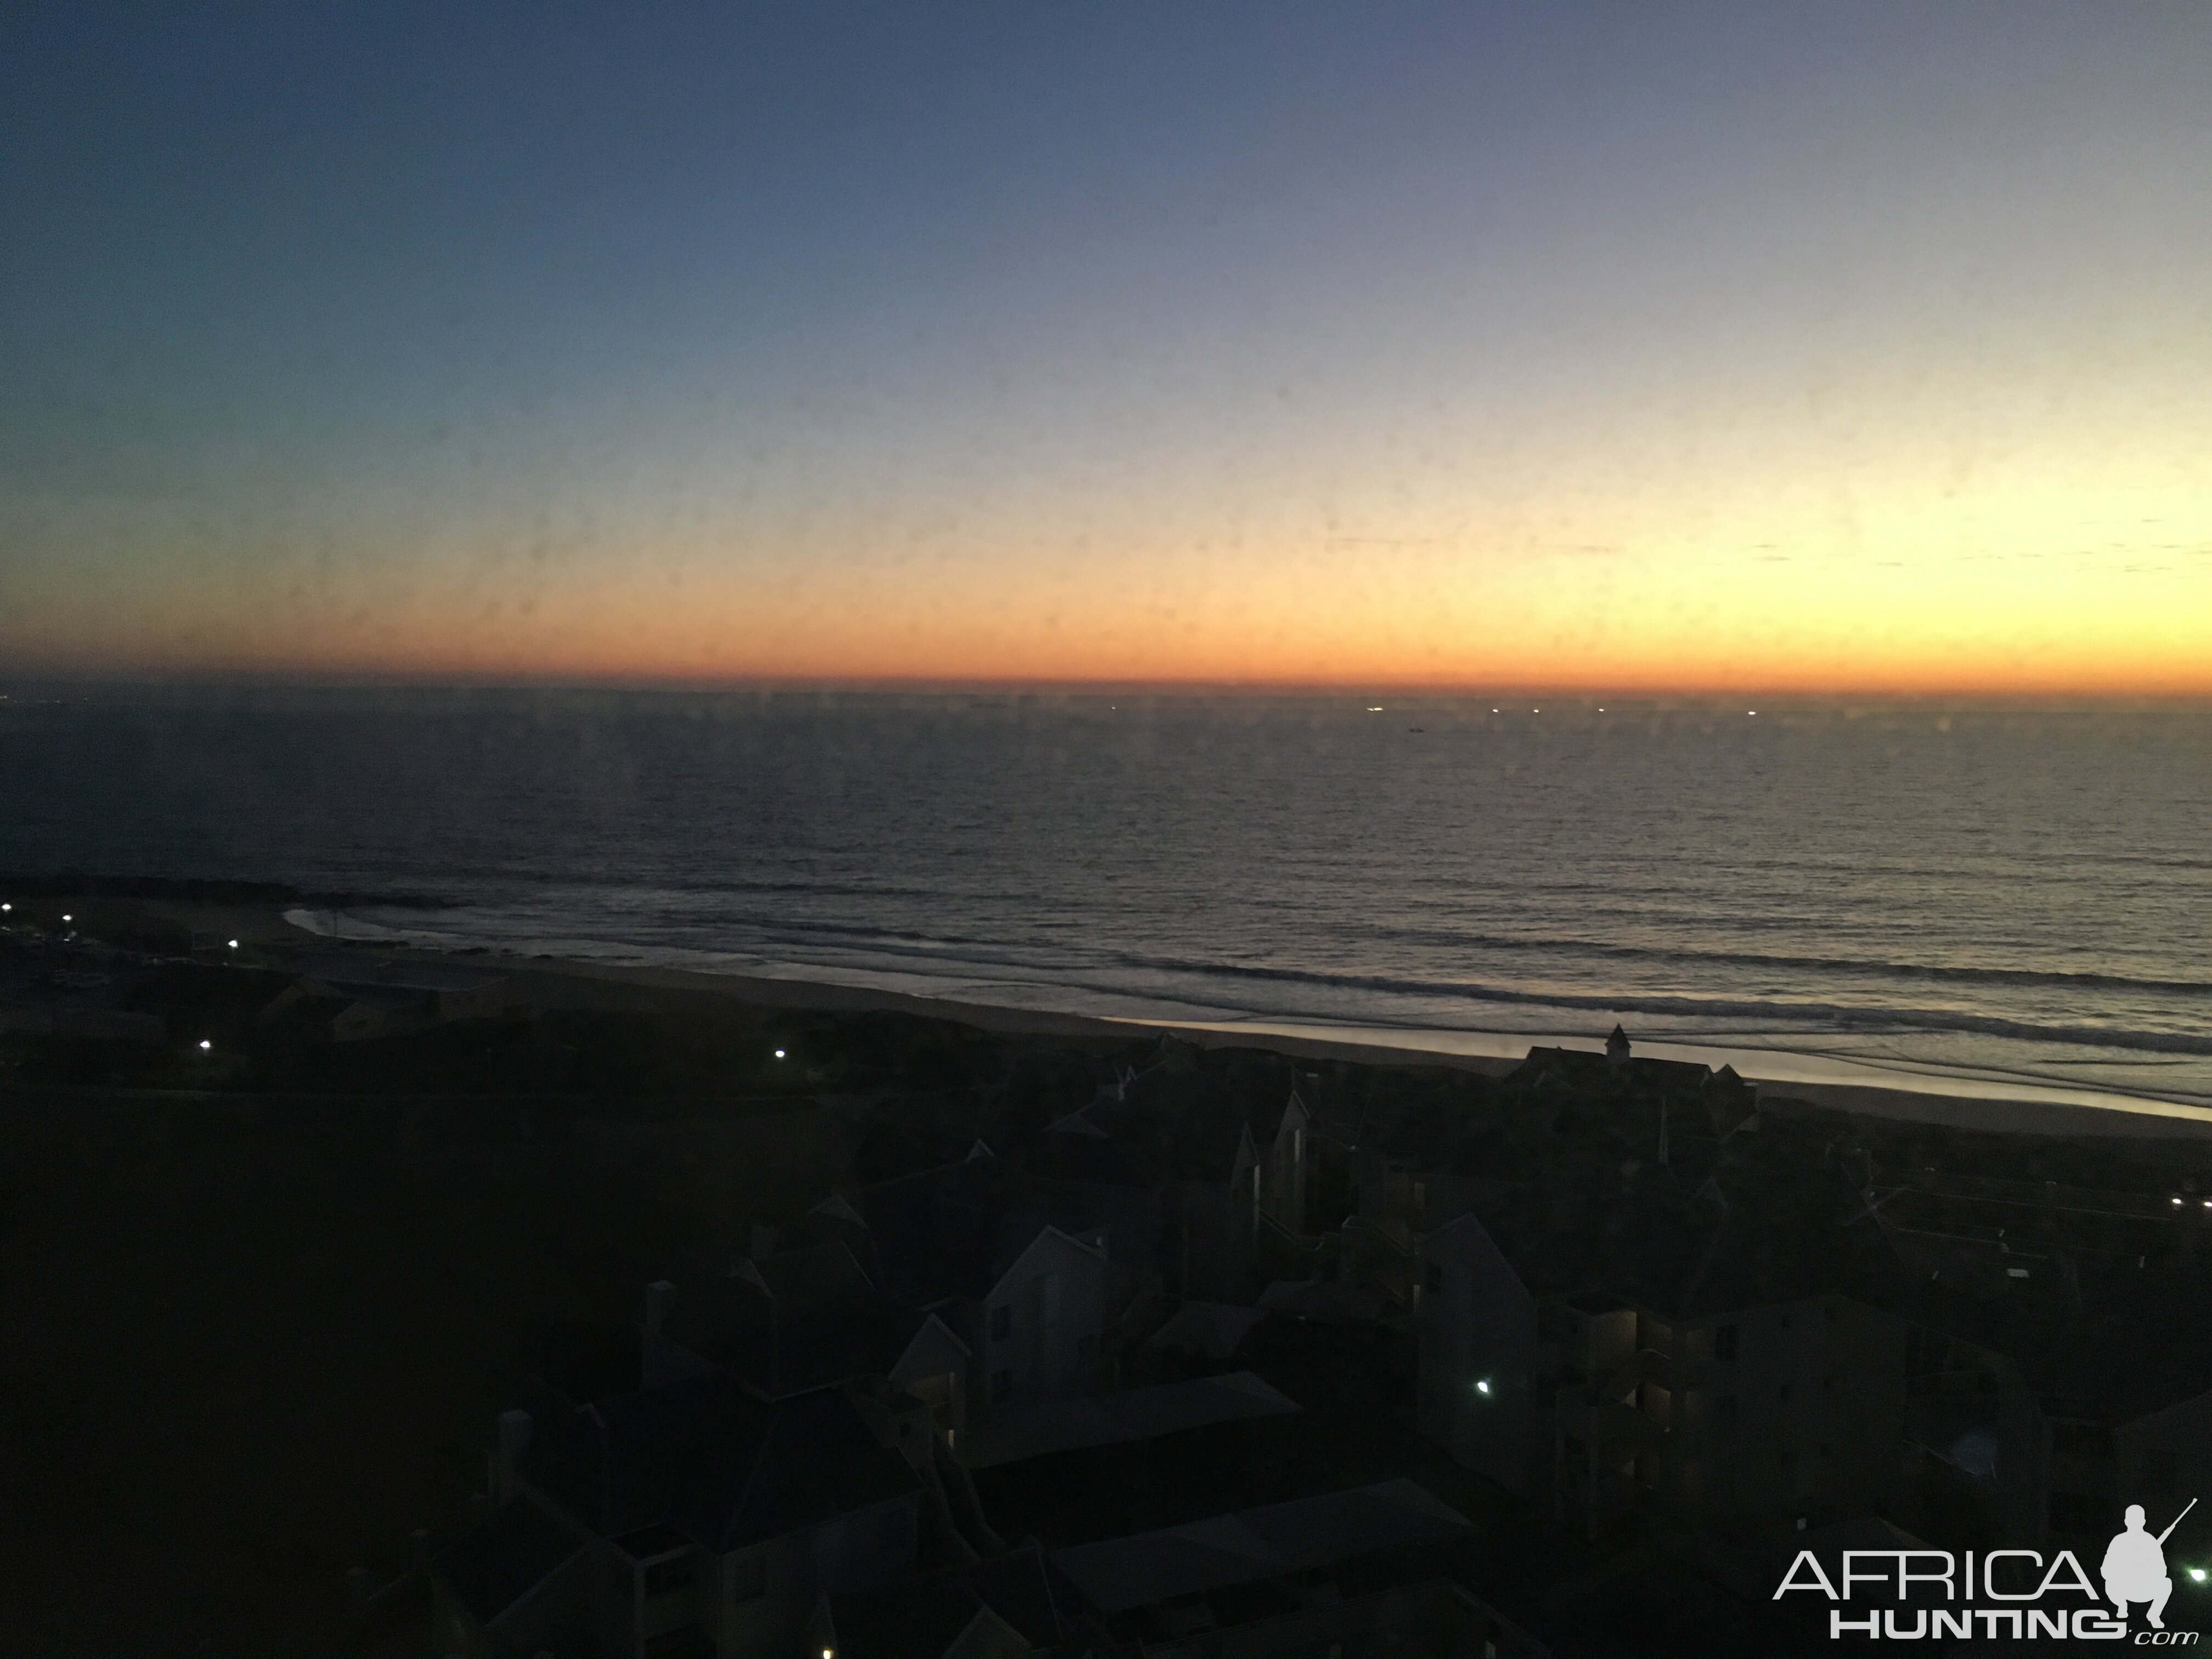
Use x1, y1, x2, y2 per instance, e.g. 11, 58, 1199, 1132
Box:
1418, 1135, 1907, 1571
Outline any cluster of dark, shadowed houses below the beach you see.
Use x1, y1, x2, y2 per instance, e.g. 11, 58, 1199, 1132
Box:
433, 1031, 2212, 1659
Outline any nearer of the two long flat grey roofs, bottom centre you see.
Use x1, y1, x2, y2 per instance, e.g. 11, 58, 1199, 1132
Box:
1051, 1480, 1471, 1612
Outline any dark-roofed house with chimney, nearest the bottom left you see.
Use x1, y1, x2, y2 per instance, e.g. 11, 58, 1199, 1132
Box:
431, 1376, 922, 1659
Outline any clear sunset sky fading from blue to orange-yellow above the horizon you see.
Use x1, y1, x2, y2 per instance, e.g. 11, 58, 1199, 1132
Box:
0, 0, 2212, 695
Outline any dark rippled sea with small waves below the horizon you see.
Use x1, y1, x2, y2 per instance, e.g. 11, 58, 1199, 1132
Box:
0, 692, 2212, 1119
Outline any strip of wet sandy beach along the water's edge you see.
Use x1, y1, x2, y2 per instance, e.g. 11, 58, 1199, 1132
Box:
17, 896, 2212, 1139
